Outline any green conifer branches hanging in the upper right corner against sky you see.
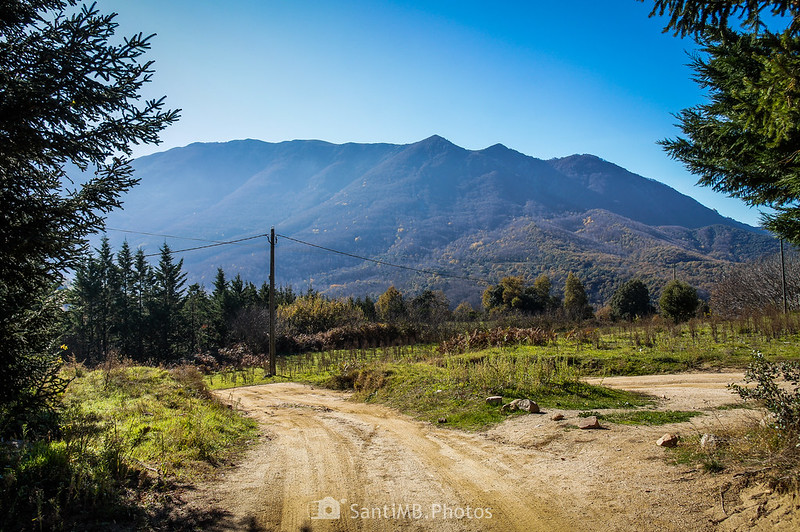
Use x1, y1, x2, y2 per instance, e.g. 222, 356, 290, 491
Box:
651, 0, 800, 243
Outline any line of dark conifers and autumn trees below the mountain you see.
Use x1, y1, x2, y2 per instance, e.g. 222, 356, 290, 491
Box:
63, 238, 716, 362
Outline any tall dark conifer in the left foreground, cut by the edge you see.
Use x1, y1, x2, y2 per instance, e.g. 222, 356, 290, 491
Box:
0, 0, 178, 432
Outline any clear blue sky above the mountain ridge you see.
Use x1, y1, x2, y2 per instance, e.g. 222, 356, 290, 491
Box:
103, 0, 759, 225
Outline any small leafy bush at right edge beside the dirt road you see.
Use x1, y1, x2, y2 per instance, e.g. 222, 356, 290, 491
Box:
731, 351, 800, 438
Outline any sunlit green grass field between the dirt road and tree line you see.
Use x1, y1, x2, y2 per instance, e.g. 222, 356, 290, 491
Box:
206, 314, 800, 430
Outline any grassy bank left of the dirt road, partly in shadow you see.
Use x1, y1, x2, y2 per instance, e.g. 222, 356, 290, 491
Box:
0, 365, 256, 530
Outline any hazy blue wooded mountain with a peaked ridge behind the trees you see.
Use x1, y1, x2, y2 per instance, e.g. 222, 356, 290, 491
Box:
95, 136, 775, 304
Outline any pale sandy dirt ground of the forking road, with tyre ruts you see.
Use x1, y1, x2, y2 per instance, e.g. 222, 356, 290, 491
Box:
189, 373, 800, 531
